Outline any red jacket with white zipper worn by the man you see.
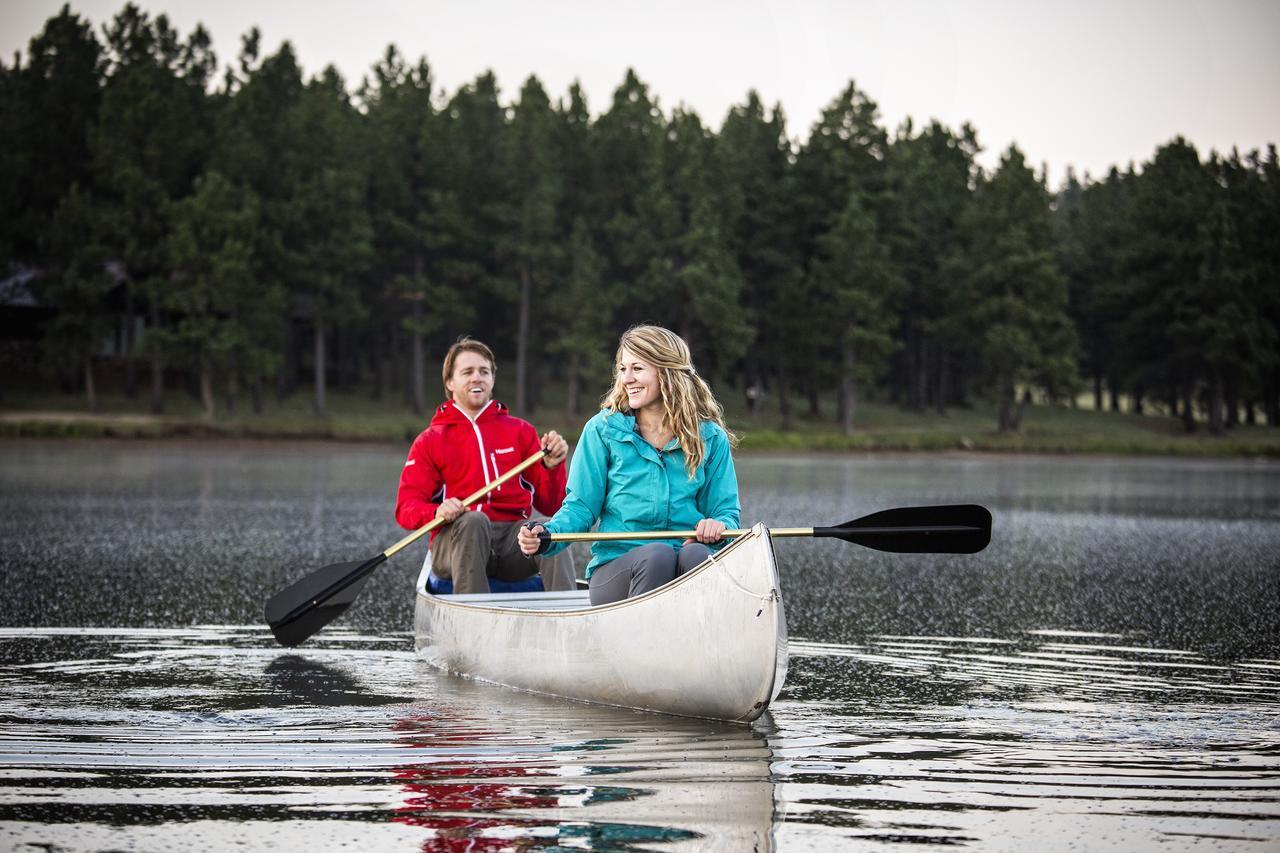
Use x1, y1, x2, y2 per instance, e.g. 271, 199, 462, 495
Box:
396, 400, 568, 538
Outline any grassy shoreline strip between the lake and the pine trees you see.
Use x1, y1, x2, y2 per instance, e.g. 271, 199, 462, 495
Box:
0, 393, 1280, 459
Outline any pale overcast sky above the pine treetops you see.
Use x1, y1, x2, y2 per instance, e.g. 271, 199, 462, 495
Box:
0, 0, 1280, 187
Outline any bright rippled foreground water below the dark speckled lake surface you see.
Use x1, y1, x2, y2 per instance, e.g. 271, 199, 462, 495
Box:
0, 626, 1280, 850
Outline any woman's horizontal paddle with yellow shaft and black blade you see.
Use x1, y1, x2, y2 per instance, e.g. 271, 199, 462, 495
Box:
538, 503, 991, 553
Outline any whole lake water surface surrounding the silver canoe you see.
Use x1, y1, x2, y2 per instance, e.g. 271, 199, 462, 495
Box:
0, 441, 1280, 853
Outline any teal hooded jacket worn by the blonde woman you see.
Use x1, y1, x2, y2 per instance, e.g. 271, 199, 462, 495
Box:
545, 410, 741, 578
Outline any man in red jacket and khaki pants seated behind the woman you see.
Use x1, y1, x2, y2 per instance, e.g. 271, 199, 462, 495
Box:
396, 338, 576, 594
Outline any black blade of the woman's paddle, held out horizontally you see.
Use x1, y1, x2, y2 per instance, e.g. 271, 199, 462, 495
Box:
813, 503, 991, 553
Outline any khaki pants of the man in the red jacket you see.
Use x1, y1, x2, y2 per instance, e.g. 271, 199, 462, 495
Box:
431, 510, 577, 594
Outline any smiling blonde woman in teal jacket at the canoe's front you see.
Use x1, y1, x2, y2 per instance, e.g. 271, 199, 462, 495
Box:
520, 325, 739, 605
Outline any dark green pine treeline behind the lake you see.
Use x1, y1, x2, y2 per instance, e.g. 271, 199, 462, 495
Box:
0, 5, 1280, 432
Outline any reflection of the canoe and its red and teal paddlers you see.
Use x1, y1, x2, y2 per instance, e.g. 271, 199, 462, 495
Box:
392, 675, 774, 850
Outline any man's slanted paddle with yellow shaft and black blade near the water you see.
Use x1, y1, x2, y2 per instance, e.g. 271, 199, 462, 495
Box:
265, 451, 547, 646
